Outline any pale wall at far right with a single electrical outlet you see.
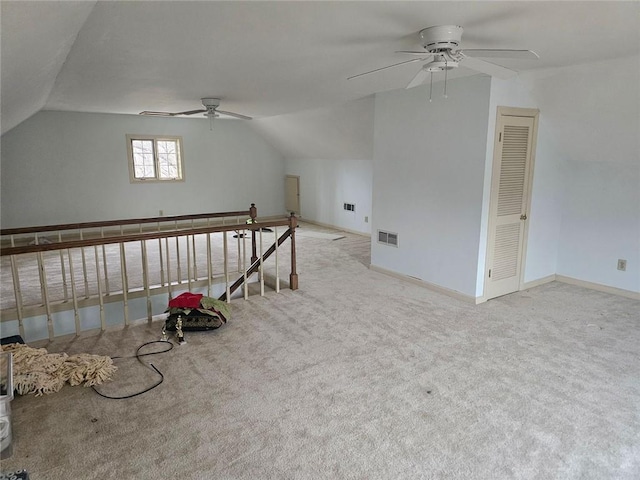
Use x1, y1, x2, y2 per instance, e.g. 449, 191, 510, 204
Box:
524, 56, 640, 292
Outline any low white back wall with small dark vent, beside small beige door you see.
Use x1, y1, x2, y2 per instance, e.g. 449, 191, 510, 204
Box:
285, 159, 372, 234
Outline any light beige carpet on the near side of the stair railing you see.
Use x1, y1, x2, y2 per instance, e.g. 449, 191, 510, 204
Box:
3, 226, 640, 480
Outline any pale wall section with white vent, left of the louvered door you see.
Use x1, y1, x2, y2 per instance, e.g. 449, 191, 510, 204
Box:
371, 76, 491, 298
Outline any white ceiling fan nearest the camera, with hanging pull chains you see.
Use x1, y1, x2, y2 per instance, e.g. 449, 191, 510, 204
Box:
348, 25, 540, 99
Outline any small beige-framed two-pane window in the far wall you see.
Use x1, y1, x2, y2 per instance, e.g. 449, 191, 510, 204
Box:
127, 135, 184, 182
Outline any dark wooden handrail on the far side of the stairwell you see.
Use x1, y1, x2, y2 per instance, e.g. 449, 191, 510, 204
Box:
0, 208, 255, 236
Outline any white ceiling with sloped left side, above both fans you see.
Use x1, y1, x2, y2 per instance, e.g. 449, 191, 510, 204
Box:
0, 1, 640, 133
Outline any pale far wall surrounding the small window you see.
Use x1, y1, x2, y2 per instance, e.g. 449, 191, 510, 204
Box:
0, 111, 284, 228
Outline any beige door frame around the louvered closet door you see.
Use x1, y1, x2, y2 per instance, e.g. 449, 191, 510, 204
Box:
480, 106, 540, 302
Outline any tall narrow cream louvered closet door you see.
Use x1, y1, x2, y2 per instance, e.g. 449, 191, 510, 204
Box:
485, 115, 534, 298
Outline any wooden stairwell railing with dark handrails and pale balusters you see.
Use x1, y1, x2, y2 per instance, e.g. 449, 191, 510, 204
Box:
0, 204, 297, 339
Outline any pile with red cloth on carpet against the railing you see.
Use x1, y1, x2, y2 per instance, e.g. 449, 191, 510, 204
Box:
165, 292, 230, 331
